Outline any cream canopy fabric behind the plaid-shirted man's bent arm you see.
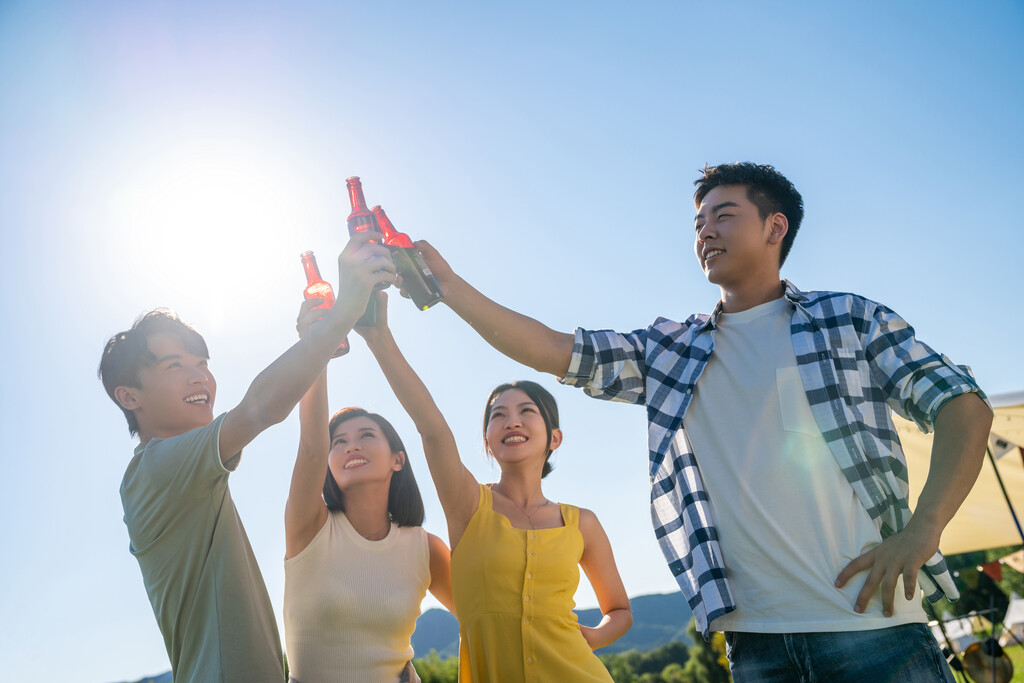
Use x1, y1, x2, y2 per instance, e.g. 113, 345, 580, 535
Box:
893, 392, 1024, 555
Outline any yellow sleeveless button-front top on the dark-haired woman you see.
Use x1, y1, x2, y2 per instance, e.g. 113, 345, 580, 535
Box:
452, 484, 612, 683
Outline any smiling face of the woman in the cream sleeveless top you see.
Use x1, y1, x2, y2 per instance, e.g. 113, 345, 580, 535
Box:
328, 417, 404, 492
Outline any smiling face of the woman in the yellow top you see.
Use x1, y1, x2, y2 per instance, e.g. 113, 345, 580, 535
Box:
484, 389, 562, 475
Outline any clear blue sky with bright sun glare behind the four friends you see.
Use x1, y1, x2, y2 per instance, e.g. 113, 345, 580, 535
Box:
0, 0, 1024, 683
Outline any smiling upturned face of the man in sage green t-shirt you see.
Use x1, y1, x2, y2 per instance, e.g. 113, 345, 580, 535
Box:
115, 332, 217, 441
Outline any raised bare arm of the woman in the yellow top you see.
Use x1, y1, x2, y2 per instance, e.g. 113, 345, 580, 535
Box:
356, 292, 480, 550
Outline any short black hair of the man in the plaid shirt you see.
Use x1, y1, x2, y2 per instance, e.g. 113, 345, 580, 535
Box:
693, 161, 804, 267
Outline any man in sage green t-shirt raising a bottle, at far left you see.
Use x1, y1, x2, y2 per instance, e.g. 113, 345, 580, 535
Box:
99, 234, 395, 683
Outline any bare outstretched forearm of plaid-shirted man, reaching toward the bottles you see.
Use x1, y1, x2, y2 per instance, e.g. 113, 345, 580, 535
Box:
416, 241, 573, 377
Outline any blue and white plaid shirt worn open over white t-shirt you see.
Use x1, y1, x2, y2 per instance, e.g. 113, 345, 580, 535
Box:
561, 282, 985, 637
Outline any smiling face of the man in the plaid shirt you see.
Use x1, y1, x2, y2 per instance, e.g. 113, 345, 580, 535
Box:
693, 185, 785, 288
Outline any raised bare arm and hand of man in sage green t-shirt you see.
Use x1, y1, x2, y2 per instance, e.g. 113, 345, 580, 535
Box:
220, 233, 396, 462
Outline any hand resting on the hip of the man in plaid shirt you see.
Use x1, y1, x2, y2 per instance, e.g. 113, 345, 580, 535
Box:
836, 519, 941, 616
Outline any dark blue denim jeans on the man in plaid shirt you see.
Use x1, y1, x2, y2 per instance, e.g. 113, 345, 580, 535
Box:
725, 624, 955, 683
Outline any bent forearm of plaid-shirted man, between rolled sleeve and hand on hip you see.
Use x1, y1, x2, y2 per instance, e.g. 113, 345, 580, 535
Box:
911, 393, 992, 538
